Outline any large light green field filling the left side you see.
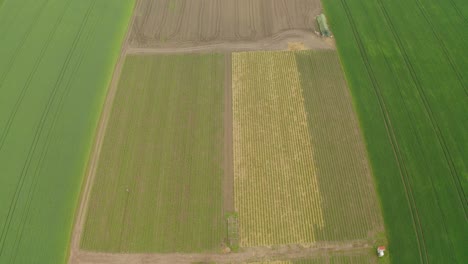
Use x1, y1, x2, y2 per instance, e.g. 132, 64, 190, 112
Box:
0, 0, 133, 263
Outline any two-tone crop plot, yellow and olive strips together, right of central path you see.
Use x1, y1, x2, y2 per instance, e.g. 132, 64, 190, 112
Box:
232, 51, 383, 247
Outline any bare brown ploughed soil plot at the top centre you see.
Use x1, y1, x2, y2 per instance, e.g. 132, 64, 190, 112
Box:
130, 0, 321, 47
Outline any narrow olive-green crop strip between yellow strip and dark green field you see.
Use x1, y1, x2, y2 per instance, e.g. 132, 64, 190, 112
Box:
295, 51, 383, 241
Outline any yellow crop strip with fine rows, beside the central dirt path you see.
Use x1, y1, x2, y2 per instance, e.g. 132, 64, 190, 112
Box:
232, 52, 324, 246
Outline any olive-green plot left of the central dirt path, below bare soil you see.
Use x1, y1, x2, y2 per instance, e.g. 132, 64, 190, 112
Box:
82, 55, 227, 252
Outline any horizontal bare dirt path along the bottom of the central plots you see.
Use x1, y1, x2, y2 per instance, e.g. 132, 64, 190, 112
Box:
75, 241, 372, 264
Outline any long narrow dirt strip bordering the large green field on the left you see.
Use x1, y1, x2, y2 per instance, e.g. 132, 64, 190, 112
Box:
68, 0, 140, 264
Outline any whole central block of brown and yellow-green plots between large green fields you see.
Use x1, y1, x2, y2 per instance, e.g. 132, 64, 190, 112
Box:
63, 0, 388, 264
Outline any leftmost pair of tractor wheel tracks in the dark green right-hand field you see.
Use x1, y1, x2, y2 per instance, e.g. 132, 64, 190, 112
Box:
341, 0, 428, 263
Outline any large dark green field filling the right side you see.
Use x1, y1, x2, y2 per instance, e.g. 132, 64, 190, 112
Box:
323, 0, 468, 263
